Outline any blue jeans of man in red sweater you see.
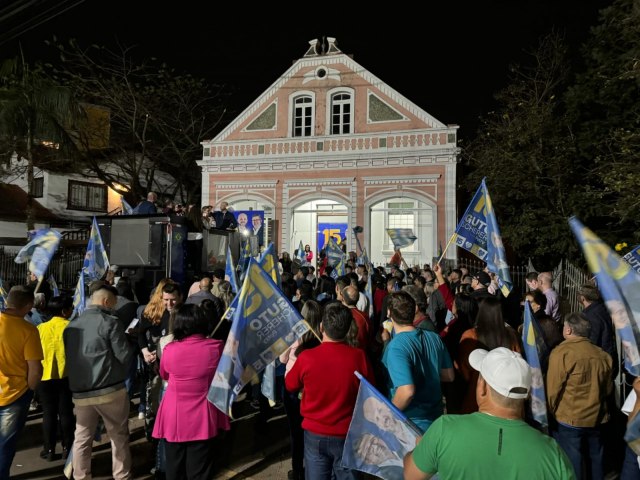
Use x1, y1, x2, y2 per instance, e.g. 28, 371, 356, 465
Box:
304, 430, 361, 480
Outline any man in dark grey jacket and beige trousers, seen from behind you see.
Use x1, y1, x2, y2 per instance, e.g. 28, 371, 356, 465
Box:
63, 284, 133, 480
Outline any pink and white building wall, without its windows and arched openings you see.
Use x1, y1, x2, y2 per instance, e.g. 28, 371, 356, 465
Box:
199, 40, 459, 262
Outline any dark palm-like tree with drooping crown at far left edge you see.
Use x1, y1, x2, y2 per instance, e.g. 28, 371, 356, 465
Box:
0, 51, 81, 230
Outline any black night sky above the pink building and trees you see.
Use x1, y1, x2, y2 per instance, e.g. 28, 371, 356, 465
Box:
0, 0, 610, 138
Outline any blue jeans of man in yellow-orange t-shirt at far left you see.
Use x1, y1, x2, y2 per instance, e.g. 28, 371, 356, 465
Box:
0, 390, 33, 480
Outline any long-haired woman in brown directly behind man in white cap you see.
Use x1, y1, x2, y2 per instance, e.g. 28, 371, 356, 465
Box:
456, 297, 522, 413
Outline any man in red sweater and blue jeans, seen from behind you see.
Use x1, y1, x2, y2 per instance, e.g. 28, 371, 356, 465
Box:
285, 302, 374, 480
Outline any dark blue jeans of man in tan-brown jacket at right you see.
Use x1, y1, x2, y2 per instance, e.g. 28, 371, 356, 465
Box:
553, 423, 604, 479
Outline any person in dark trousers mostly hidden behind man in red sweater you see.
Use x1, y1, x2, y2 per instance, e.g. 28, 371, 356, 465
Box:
280, 300, 323, 480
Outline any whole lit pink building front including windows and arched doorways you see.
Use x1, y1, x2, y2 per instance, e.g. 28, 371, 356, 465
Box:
198, 38, 459, 264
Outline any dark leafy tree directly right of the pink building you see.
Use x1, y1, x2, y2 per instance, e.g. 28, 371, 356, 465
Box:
463, 33, 588, 266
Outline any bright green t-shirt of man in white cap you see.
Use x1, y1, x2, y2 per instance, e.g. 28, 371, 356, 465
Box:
413, 413, 575, 480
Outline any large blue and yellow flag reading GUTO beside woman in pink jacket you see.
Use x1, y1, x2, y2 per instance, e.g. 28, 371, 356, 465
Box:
207, 259, 309, 416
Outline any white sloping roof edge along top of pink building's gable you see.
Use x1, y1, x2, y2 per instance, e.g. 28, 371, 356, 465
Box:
212, 37, 447, 143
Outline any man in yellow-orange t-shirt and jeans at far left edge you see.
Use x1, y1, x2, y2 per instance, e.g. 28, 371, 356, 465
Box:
0, 286, 44, 480
